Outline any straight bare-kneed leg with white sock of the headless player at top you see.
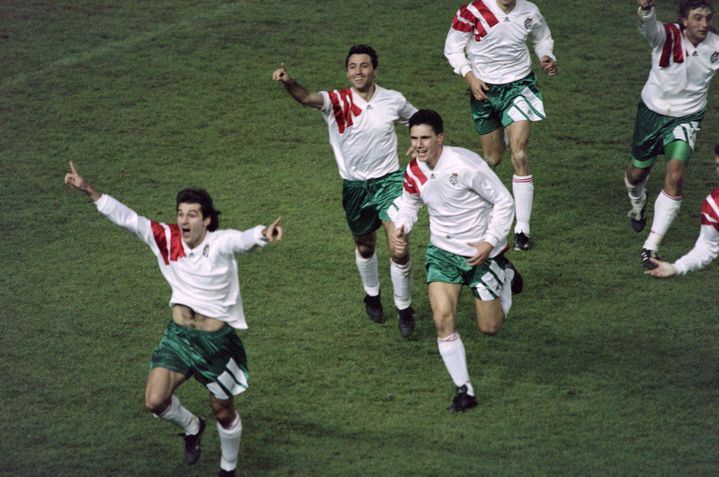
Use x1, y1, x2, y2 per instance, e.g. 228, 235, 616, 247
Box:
507, 120, 534, 251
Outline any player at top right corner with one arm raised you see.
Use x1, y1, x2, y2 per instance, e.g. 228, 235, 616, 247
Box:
624, 0, 719, 269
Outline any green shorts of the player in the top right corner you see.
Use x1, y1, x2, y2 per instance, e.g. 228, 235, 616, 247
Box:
632, 100, 704, 169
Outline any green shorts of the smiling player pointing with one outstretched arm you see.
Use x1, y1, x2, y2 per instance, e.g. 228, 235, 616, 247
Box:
342, 170, 404, 235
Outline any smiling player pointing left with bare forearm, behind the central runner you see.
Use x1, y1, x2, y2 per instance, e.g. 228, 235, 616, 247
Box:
272, 45, 417, 338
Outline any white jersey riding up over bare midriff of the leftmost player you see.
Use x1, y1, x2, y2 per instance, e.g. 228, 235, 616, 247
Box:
95, 194, 267, 329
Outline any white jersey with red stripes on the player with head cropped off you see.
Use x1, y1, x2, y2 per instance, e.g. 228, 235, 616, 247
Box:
444, 0, 555, 84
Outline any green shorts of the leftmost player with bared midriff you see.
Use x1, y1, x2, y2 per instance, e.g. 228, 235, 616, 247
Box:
150, 321, 250, 399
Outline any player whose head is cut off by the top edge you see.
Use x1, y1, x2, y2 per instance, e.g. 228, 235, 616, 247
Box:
444, 0, 558, 251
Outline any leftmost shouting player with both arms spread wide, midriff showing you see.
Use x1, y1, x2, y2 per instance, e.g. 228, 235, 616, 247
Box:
65, 162, 282, 477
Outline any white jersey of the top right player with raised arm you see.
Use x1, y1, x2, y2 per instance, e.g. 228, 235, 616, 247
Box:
639, 8, 719, 118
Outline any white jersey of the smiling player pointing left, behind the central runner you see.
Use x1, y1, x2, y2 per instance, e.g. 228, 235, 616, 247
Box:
320, 84, 417, 180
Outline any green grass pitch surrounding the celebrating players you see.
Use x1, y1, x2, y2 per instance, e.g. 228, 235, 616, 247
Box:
0, 0, 719, 477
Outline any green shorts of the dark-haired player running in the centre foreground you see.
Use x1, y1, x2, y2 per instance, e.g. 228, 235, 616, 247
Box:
424, 244, 508, 301
